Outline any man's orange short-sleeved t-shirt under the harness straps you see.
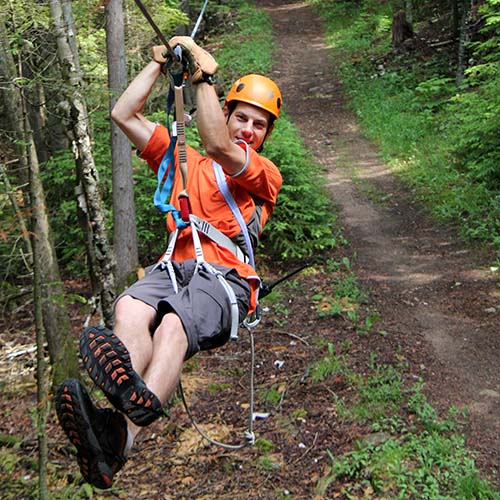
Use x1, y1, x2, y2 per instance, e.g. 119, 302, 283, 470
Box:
141, 125, 282, 313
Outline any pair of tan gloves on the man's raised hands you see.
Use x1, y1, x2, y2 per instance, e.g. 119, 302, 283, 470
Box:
152, 36, 219, 83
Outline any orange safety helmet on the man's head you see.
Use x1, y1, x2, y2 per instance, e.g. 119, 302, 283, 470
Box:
225, 75, 282, 119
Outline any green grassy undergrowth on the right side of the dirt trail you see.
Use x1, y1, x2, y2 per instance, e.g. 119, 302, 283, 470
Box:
310, 0, 500, 255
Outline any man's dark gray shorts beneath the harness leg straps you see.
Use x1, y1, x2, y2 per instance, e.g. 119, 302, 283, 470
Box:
117, 259, 250, 359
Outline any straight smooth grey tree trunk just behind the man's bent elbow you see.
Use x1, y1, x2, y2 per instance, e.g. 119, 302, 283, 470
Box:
106, 0, 139, 292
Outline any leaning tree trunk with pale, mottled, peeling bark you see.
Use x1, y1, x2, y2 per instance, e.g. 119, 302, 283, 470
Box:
50, 0, 115, 326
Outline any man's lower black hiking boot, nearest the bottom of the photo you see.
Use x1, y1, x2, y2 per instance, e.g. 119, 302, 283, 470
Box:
56, 379, 128, 489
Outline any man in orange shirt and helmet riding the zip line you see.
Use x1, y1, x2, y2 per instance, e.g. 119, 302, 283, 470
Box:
56, 37, 281, 488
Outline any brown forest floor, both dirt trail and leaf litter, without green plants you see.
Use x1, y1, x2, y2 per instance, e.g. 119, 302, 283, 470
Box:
0, 0, 500, 500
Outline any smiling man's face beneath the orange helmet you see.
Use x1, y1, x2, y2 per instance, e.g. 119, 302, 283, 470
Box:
224, 102, 270, 150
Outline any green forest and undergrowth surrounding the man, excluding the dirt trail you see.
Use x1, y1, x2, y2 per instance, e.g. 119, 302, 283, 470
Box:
0, 0, 500, 500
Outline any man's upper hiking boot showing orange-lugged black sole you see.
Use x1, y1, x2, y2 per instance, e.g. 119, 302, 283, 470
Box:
80, 326, 163, 427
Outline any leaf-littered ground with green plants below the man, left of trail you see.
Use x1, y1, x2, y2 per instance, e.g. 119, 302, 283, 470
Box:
0, 251, 500, 500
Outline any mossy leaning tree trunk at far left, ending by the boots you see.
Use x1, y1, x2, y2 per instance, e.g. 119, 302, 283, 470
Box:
0, 15, 78, 384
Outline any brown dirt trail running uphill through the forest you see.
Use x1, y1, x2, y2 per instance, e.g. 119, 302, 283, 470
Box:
256, 0, 500, 478
